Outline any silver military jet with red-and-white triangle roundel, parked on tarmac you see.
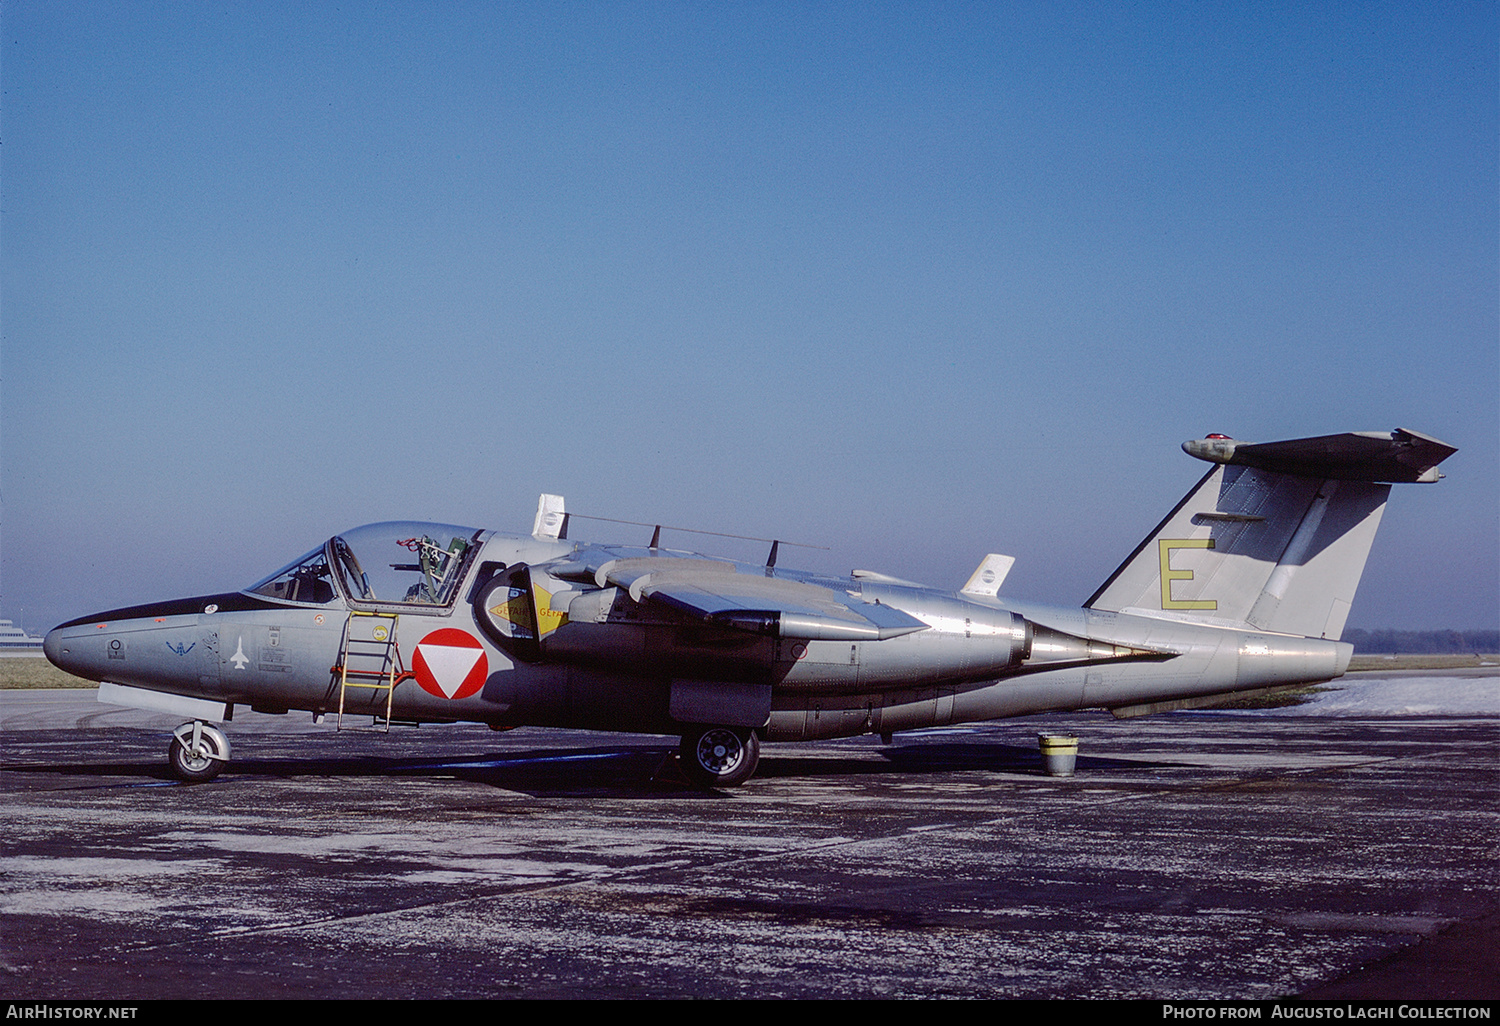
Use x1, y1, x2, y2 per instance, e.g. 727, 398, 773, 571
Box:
45, 429, 1457, 786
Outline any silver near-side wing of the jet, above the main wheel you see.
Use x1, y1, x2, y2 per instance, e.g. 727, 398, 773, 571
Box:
552, 552, 927, 641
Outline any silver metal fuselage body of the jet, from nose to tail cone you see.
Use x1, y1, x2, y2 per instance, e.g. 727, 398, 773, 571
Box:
47, 531, 1353, 741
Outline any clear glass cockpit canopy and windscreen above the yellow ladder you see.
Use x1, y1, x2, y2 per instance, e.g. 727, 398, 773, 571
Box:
246, 521, 480, 606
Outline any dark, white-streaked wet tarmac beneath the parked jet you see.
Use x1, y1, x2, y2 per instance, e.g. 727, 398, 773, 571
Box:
0, 681, 1500, 1001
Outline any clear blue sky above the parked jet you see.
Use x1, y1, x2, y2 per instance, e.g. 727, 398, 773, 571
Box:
0, 0, 1500, 632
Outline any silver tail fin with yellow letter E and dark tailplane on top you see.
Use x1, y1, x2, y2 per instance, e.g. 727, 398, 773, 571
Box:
1085, 429, 1458, 641
